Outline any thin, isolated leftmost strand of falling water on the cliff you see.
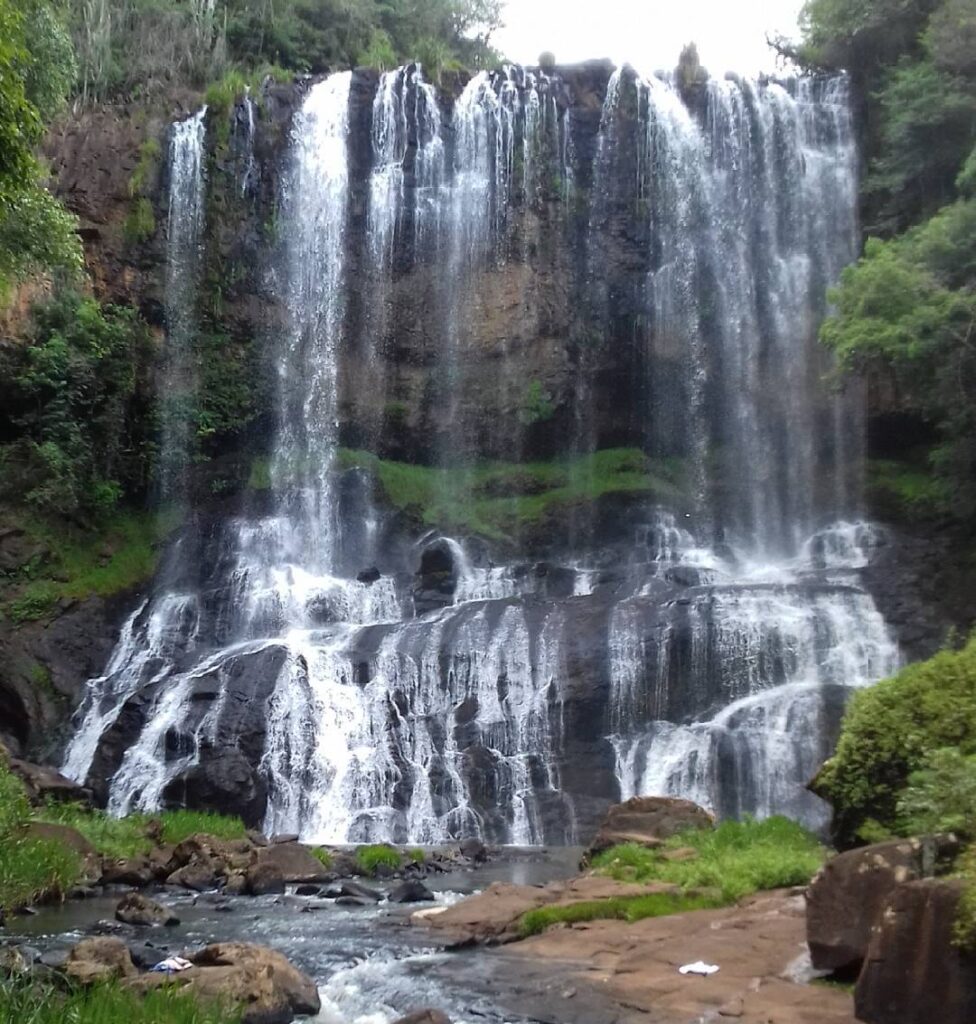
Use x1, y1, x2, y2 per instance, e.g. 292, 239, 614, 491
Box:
159, 106, 207, 500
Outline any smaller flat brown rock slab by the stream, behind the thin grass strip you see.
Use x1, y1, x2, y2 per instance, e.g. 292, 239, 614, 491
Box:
414, 874, 676, 945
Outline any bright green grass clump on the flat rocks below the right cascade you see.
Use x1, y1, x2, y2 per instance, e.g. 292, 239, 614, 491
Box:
593, 817, 826, 903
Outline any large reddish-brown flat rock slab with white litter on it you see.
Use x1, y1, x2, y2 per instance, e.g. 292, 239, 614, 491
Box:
499, 891, 855, 1024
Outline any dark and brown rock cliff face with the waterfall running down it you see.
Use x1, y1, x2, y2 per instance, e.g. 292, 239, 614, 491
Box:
0, 63, 941, 842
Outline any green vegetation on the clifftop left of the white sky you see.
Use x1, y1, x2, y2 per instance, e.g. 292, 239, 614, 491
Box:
70, 0, 502, 103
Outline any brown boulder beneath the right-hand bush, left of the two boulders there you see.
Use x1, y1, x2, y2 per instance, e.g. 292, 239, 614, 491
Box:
807, 837, 958, 972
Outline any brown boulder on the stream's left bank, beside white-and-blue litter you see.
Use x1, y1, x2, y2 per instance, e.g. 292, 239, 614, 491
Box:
129, 942, 321, 1024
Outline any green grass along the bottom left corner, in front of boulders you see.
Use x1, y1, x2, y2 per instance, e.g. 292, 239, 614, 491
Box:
0, 979, 241, 1024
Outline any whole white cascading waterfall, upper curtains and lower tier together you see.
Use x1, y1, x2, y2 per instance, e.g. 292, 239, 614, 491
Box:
66, 65, 897, 844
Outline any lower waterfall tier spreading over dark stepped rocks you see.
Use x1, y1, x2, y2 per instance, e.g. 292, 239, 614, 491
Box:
60, 514, 898, 844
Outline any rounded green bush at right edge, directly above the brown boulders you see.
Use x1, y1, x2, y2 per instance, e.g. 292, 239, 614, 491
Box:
812, 637, 976, 847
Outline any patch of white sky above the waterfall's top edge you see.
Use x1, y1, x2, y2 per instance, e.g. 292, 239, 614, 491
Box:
492, 0, 802, 75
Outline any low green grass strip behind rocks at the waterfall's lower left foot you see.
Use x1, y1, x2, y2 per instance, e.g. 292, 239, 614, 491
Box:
38, 803, 245, 858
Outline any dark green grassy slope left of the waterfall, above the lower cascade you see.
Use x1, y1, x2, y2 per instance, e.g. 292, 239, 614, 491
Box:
3, 511, 178, 624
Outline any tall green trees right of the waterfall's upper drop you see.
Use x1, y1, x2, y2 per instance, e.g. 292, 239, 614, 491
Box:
777, 0, 976, 512
